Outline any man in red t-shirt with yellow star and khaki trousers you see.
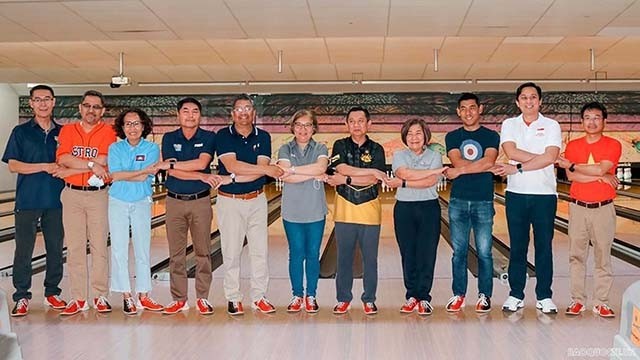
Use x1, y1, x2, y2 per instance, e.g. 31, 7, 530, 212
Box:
558, 102, 622, 317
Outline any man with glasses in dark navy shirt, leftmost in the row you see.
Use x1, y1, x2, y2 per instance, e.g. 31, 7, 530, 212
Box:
2, 85, 67, 316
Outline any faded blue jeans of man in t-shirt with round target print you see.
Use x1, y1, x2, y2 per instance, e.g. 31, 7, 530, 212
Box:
449, 198, 495, 297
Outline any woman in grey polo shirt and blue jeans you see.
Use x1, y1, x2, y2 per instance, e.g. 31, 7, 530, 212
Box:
278, 110, 329, 313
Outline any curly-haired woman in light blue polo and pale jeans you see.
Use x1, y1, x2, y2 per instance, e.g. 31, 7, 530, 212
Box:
108, 108, 163, 315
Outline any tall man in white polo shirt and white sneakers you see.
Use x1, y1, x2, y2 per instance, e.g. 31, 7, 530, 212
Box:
493, 82, 562, 314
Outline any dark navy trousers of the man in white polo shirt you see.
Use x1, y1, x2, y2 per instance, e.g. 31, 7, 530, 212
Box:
505, 191, 558, 300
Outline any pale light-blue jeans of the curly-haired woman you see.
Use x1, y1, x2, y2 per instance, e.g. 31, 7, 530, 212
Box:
109, 196, 151, 293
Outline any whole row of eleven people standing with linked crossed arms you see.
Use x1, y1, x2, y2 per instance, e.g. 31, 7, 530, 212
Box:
3, 83, 621, 316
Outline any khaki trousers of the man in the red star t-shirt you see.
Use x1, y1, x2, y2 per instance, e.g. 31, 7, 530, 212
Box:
569, 203, 616, 304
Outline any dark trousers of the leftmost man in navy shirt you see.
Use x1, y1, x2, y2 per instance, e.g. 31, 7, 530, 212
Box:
13, 209, 64, 301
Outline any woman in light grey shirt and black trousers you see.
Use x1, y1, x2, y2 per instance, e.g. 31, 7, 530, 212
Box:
388, 119, 445, 315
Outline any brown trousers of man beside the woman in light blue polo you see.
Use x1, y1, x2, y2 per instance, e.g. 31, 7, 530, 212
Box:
166, 196, 213, 301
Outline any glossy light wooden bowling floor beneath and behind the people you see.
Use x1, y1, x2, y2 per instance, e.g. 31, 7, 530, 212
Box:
0, 183, 640, 360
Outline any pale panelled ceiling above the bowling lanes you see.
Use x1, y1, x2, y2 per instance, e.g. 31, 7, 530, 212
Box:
0, 0, 640, 94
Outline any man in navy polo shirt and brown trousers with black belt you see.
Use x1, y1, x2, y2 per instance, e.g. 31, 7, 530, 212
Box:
158, 98, 219, 315
